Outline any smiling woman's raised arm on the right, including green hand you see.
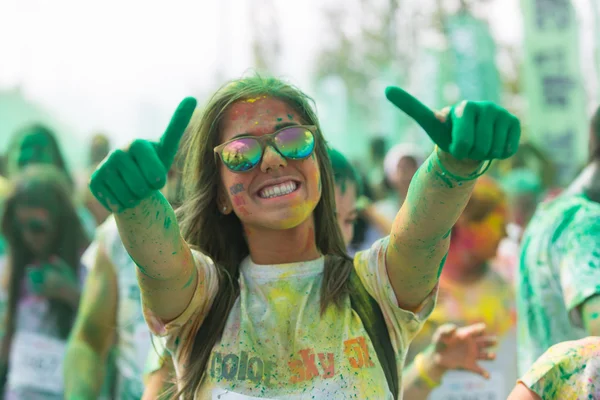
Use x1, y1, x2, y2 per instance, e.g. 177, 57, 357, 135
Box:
386, 88, 520, 310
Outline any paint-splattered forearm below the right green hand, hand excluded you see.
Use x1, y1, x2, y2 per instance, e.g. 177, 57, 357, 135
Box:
386, 151, 480, 311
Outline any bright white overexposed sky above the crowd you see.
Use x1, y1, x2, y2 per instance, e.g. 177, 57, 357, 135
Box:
0, 0, 583, 152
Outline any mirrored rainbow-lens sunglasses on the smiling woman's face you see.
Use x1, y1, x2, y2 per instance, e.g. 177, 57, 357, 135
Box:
214, 125, 317, 172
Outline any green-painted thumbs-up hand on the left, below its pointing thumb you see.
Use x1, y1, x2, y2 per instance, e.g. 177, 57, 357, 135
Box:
89, 97, 196, 212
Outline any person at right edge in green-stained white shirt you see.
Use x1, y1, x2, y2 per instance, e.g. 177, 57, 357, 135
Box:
517, 108, 600, 376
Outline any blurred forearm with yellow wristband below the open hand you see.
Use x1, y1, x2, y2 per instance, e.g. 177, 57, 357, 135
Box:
403, 348, 446, 400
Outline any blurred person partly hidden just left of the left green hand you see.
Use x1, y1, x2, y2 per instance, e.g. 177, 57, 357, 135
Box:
79, 134, 110, 226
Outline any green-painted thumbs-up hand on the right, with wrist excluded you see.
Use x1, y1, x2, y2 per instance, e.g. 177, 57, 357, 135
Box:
385, 86, 521, 161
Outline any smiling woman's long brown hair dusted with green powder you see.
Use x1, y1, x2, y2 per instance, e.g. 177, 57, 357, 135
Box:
173, 76, 353, 398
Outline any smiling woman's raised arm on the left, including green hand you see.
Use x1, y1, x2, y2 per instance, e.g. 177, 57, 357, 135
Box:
90, 98, 202, 322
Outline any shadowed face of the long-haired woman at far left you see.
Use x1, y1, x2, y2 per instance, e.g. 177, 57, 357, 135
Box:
16, 206, 54, 257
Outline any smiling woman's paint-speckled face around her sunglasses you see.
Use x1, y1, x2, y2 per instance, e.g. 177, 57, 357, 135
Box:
219, 96, 321, 229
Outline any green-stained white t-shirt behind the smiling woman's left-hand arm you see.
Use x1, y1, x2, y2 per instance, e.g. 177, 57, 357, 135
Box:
83, 216, 152, 400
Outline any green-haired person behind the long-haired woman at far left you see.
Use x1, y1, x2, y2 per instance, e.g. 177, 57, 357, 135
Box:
7, 124, 96, 240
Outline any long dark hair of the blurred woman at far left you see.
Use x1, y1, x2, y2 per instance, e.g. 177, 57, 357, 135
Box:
1, 165, 89, 357
